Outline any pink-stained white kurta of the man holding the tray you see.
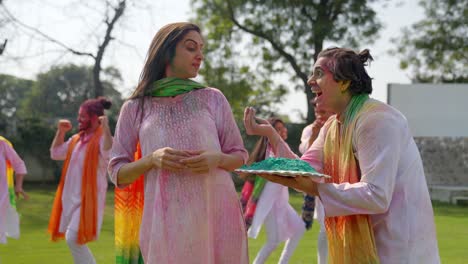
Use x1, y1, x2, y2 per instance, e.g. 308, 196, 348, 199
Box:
276, 99, 440, 264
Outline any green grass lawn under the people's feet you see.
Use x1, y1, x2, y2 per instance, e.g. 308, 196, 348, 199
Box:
0, 186, 468, 264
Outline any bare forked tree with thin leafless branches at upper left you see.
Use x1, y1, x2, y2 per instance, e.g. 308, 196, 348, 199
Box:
0, 0, 127, 97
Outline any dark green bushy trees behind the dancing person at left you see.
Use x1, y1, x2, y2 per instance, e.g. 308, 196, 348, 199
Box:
0, 64, 122, 184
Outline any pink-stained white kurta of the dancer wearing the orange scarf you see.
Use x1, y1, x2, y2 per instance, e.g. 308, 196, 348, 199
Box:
50, 135, 110, 237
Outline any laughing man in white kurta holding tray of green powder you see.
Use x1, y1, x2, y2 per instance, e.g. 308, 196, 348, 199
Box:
244, 48, 440, 264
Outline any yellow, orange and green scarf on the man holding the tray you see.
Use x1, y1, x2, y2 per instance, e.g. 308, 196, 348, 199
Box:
324, 95, 379, 264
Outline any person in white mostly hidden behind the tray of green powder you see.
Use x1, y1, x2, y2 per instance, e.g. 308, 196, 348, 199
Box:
247, 119, 305, 264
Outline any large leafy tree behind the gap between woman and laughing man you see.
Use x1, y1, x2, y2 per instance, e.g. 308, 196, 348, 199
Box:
193, 0, 381, 122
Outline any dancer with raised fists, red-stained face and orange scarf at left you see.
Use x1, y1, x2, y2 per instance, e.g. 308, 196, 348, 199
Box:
50, 98, 112, 264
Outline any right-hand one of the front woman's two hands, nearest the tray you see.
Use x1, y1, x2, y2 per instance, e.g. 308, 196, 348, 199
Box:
181, 150, 222, 174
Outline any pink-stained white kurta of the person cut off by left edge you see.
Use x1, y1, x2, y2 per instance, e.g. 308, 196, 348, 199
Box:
0, 140, 27, 243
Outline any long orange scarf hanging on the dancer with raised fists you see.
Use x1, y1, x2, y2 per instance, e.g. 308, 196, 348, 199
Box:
48, 127, 102, 245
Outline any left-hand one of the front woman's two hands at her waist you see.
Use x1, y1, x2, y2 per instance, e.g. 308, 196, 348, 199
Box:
151, 147, 190, 171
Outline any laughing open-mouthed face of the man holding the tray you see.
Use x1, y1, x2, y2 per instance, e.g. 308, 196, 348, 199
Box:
307, 57, 349, 113
